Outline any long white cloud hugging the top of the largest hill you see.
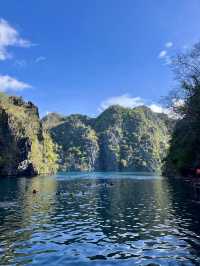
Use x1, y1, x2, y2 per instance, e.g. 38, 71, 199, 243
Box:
98, 94, 169, 113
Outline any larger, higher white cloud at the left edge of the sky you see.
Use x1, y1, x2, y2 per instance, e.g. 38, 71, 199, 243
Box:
0, 19, 31, 60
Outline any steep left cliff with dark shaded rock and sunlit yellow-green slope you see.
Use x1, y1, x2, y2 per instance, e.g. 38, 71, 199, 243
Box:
0, 93, 57, 176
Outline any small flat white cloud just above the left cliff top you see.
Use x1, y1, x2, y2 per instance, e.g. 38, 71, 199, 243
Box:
0, 75, 31, 92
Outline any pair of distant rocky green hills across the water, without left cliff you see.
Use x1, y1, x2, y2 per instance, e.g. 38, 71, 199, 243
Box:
42, 105, 173, 172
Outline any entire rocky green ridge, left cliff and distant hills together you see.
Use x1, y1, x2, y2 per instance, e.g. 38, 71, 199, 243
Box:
0, 93, 173, 176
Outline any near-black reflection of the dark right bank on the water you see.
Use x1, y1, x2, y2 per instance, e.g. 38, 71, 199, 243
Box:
168, 178, 200, 258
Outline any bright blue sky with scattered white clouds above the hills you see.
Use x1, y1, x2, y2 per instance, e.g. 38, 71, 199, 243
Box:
0, 0, 200, 116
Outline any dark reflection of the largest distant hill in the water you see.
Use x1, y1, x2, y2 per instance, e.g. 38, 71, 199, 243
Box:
94, 179, 173, 241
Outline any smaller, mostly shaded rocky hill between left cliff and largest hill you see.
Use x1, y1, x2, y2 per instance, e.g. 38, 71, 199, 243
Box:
51, 116, 99, 171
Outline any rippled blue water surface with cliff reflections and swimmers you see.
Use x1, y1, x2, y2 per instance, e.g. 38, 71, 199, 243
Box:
0, 173, 200, 266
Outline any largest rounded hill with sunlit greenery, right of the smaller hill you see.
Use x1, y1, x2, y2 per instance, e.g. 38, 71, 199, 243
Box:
96, 106, 170, 171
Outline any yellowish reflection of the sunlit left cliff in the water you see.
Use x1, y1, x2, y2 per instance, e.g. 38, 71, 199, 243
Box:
0, 177, 57, 265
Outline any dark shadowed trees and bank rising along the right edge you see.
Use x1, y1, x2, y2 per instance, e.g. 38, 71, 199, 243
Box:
165, 43, 200, 175
